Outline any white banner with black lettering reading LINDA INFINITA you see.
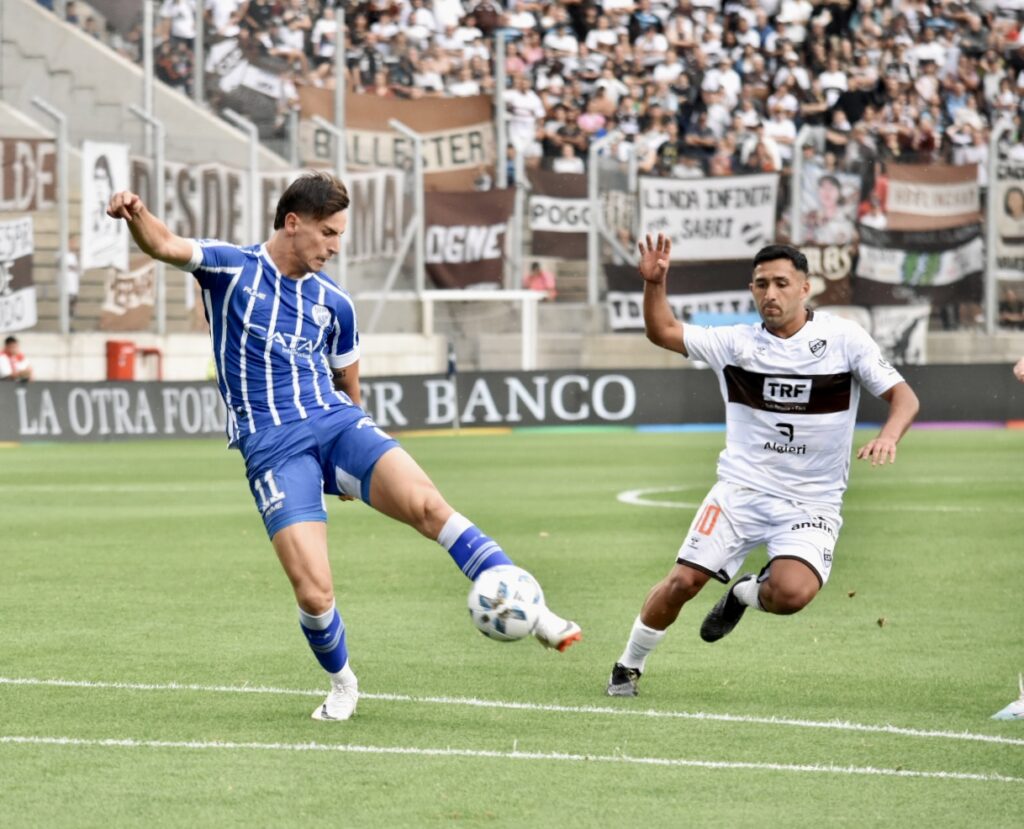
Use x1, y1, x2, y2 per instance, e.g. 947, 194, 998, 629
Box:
640, 173, 778, 260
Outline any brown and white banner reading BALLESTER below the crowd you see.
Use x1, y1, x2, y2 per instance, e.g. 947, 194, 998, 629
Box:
299, 86, 497, 190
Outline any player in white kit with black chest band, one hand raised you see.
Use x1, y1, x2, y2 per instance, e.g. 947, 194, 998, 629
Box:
607, 233, 918, 696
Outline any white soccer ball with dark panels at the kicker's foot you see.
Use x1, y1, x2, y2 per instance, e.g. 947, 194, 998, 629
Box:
467, 564, 544, 642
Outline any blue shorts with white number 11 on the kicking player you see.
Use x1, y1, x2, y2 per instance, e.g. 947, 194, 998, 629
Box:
239, 406, 398, 538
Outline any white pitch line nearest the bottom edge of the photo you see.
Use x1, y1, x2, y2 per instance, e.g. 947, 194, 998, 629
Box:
0, 735, 1024, 783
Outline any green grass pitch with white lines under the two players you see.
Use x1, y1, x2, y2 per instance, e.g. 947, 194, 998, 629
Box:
0, 430, 1024, 829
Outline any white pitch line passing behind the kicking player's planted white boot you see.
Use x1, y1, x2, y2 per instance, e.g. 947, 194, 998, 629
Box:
0, 677, 1024, 746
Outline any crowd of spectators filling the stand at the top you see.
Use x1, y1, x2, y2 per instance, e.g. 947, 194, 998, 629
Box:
48, 0, 1024, 189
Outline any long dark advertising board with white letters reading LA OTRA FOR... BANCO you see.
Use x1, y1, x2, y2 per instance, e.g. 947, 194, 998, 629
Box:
6, 364, 1024, 440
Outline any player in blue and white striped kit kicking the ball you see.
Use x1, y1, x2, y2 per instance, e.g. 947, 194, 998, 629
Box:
106, 173, 581, 721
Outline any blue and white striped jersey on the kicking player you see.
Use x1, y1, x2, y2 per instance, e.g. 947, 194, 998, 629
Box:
183, 239, 359, 446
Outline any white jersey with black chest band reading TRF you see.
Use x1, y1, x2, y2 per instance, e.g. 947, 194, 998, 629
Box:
684, 311, 903, 508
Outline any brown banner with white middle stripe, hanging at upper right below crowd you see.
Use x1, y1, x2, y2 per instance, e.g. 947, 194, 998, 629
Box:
885, 164, 981, 230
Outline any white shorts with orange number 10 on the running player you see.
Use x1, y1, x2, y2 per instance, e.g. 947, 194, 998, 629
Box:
676, 474, 843, 585
